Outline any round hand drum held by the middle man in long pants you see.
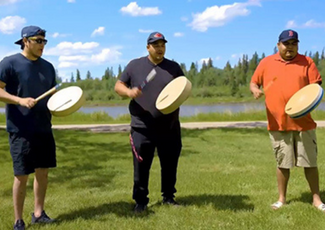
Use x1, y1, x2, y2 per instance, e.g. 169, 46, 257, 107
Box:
156, 76, 192, 114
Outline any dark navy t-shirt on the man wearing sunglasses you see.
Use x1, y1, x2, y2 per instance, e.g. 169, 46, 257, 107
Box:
0, 53, 56, 133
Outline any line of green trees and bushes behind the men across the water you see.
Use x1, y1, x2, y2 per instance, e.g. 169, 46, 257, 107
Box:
57, 47, 325, 101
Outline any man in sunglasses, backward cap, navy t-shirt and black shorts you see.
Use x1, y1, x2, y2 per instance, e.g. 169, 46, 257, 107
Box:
0, 26, 56, 230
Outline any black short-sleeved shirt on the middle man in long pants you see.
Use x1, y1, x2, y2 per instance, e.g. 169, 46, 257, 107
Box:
120, 56, 184, 129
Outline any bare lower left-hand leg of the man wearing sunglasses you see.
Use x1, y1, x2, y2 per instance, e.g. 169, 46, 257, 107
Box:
12, 175, 28, 223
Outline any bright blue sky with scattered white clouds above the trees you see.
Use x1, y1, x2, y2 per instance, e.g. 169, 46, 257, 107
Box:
0, 0, 325, 79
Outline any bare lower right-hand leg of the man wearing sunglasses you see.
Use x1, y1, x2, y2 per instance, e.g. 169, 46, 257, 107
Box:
34, 168, 49, 217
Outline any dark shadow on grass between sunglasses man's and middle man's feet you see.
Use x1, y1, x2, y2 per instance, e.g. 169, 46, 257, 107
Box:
56, 201, 154, 223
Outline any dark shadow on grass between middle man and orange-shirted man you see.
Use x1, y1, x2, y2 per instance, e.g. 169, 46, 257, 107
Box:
177, 194, 254, 212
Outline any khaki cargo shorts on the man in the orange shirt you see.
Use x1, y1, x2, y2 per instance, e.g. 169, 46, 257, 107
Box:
269, 129, 317, 169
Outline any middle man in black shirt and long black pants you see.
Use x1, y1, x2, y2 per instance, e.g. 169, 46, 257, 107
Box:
115, 32, 184, 212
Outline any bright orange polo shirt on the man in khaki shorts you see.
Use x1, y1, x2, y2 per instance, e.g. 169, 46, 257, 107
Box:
251, 53, 322, 131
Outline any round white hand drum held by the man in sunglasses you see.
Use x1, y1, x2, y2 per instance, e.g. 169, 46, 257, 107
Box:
47, 86, 86, 117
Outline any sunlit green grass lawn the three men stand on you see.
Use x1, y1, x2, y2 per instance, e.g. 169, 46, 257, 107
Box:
0, 129, 325, 230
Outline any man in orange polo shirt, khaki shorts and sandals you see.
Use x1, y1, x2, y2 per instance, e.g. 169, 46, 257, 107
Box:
250, 30, 325, 211
